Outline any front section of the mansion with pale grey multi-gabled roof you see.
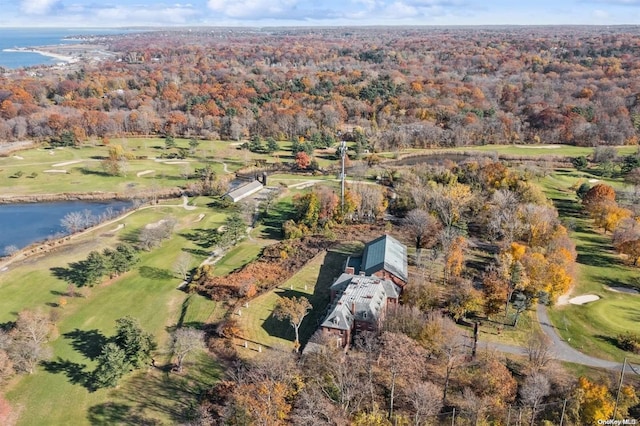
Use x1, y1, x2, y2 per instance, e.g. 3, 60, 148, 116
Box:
320, 273, 402, 347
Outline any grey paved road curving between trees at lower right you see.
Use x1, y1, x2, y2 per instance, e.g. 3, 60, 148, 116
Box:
479, 304, 640, 372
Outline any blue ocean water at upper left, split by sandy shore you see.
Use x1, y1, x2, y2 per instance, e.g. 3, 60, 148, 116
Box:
0, 28, 129, 69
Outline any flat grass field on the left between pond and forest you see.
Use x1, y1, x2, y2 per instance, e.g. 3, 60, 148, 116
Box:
0, 138, 260, 195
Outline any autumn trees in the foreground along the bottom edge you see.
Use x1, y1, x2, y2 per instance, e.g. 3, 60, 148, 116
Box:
198, 306, 638, 426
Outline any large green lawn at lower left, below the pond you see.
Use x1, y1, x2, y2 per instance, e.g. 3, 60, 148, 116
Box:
0, 199, 225, 425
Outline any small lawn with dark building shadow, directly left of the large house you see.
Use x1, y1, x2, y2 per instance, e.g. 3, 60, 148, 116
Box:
234, 246, 350, 357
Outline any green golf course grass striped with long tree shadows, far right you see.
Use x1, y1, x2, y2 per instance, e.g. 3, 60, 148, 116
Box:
543, 170, 640, 361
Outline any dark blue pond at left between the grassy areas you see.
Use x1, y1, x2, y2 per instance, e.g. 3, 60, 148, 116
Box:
0, 201, 133, 256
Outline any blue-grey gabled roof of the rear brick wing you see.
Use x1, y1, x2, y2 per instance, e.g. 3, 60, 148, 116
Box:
361, 235, 408, 282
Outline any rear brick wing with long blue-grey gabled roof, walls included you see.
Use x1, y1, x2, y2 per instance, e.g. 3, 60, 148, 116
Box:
345, 235, 409, 287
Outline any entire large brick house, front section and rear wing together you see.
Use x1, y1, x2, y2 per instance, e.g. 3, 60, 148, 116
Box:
320, 235, 408, 347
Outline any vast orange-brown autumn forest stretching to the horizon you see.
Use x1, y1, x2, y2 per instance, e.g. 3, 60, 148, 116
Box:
0, 27, 640, 151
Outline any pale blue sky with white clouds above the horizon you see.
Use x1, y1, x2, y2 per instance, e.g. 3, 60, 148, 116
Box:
0, 0, 640, 27
